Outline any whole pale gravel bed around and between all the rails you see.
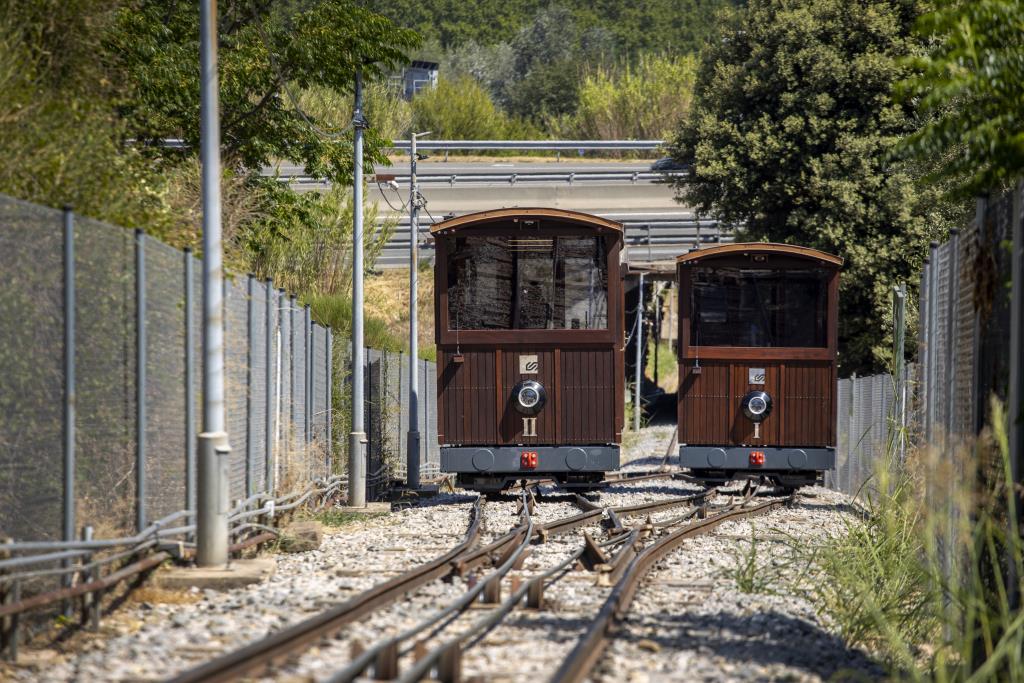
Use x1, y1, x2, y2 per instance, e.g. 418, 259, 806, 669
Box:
0, 426, 881, 683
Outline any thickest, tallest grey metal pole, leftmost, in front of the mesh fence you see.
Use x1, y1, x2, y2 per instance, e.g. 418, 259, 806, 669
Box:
196, 0, 230, 566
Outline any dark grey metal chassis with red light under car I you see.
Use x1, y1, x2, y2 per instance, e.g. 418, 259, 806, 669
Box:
679, 445, 836, 488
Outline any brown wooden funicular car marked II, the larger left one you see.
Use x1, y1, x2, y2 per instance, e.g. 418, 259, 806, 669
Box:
431, 209, 624, 492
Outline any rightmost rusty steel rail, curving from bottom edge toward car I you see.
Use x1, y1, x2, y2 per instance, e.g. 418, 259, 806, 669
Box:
551, 496, 793, 683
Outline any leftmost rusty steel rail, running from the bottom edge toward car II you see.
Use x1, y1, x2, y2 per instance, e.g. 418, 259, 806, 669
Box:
171, 499, 481, 683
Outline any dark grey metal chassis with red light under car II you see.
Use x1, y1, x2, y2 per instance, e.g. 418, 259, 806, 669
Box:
440, 443, 618, 492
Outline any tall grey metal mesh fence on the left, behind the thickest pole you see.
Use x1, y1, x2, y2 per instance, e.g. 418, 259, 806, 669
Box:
0, 197, 333, 540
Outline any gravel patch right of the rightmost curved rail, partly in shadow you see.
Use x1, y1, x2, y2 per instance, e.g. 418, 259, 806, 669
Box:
595, 486, 884, 682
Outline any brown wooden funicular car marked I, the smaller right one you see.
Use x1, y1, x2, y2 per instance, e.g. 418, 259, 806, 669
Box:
676, 244, 843, 487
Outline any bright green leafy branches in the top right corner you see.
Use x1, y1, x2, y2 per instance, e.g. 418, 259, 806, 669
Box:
899, 0, 1024, 196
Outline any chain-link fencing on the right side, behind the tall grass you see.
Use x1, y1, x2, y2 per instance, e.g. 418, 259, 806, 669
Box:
826, 184, 1024, 544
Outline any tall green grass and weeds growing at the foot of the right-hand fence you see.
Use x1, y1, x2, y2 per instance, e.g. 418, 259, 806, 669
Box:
793, 399, 1024, 683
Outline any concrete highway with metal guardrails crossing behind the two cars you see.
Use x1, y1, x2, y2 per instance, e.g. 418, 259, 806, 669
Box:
267, 158, 732, 268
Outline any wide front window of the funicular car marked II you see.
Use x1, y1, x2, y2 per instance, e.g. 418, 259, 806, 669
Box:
447, 237, 608, 330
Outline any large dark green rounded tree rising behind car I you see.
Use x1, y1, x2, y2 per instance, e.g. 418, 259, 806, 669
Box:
673, 0, 954, 373
